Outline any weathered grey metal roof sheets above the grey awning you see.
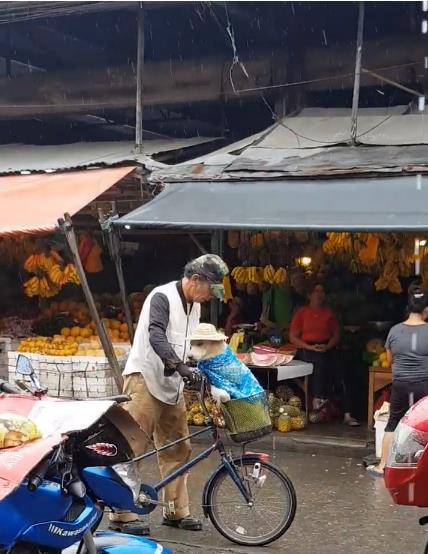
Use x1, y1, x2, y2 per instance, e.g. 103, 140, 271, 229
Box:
151, 106, 428, 182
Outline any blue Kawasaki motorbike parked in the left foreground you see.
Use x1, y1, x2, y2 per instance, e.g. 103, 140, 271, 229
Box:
0, 357, 172, 554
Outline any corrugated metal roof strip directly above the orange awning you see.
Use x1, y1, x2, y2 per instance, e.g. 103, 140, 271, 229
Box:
0, 137, 215, 175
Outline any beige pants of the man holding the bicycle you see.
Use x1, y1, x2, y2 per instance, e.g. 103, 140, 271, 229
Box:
110, 373, 191, 523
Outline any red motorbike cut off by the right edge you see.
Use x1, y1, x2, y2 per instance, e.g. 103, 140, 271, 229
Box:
385, 396, 428, 554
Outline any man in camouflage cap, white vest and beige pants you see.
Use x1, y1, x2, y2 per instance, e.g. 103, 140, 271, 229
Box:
110, 254, 228, 535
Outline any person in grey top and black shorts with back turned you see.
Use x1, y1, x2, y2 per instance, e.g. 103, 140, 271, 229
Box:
367, 284, 428, 477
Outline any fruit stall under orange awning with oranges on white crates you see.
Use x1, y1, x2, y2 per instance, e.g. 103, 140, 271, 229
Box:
0, 167, 134, 396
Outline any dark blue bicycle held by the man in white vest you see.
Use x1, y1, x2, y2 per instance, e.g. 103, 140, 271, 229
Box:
126, 378, 297, 546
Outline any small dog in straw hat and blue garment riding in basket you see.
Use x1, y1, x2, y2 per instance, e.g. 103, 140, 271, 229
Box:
189, 323, 264, 404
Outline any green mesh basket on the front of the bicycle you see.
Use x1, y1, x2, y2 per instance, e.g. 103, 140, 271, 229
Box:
220, 392, 272, 442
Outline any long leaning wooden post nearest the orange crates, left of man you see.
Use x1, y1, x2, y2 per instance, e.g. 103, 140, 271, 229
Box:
58, 214, 123, 393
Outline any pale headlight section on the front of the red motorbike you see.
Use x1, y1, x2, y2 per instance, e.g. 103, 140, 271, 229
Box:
387, 421, 428, 467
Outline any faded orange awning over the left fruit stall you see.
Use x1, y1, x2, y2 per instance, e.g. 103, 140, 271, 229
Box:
0, 166, 135, 235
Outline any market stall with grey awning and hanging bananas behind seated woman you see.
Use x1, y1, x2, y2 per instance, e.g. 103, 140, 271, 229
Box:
115, 175, 428, 438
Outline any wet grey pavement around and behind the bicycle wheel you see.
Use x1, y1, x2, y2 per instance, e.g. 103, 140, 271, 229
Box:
105, 446, 428, 554
